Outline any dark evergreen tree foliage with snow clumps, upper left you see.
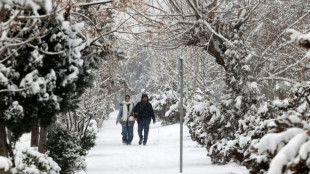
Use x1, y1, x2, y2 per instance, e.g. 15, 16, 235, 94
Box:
0, 1, 88, 138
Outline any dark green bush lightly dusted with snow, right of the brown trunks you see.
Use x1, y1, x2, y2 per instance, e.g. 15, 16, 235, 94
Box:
47, 128, 88, 174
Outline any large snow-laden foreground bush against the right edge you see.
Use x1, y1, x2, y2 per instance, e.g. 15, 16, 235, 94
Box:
243, 82, 310, 173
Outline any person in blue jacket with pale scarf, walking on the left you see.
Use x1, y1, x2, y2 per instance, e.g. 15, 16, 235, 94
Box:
116, 95, 135, 145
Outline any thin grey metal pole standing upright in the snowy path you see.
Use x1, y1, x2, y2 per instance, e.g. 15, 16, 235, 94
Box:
179, 58, 183, 173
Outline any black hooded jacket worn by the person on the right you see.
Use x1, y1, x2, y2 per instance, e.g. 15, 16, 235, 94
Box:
133, 94, 155, 122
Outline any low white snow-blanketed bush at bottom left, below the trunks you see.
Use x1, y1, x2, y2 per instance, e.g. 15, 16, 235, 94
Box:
11, 147, 60, 174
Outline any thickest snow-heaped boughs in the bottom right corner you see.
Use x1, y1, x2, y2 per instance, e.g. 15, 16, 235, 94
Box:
244, 128, 309, 174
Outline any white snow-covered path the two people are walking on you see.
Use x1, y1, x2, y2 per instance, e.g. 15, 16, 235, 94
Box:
86, 111, 248, 174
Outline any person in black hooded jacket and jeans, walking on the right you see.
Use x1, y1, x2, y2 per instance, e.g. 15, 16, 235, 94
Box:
133, 94, 156, 145
